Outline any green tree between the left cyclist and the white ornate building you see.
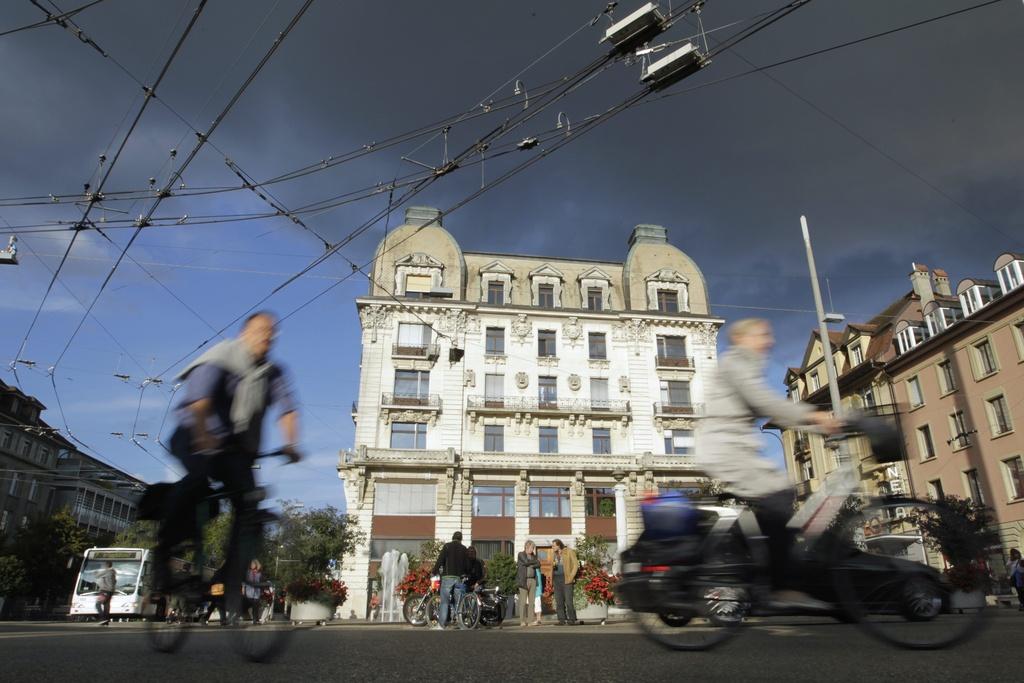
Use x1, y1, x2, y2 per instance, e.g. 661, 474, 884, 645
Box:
264, 501, 367, 583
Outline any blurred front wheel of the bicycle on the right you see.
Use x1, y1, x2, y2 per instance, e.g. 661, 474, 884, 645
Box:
830, 499, 988, 649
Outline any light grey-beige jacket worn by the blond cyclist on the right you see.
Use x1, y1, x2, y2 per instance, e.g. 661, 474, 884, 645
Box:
697, 347, 814, 497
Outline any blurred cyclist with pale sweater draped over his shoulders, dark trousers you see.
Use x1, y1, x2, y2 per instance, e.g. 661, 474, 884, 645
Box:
154, 311, 300, 610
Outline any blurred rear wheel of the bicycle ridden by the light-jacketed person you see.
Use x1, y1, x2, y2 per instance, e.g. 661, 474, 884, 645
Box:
638, 539, 753, 651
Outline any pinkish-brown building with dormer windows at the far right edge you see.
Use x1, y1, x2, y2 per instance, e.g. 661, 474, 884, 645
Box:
886, 253, 1024, 577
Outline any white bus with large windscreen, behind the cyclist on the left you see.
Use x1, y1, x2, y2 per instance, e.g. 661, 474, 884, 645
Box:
69, 548, 156, 618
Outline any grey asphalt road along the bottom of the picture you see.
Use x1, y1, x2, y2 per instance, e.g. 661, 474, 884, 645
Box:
0, 610, 1024, 683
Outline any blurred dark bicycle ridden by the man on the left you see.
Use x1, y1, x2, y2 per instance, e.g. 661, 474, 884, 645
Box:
139, 451, 293, 661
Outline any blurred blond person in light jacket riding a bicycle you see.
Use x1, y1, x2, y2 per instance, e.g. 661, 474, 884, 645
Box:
698, 318, 842, 603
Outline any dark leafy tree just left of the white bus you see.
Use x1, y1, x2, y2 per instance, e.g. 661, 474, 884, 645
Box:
11, 510, 89, 602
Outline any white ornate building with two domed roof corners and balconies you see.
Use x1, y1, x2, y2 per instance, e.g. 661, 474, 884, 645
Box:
338, 208, 722, 612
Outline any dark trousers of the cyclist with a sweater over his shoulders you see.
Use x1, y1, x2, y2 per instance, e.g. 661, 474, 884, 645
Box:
156, 427, 258, 614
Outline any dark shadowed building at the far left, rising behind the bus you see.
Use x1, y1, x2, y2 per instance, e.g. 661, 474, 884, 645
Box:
0, 381, 145, 546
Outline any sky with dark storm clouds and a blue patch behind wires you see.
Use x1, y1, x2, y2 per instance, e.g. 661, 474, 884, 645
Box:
0, 0, 1024, 505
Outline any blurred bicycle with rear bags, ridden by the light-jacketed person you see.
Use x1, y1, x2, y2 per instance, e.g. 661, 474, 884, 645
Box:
616, 422, 987, 650
